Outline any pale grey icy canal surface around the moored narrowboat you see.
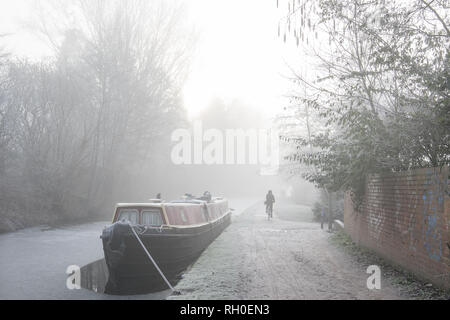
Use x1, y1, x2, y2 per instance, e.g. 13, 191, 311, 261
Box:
0, 198, 256, 299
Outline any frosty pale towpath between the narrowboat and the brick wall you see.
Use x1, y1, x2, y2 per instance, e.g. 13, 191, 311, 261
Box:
169, 202, 405, 300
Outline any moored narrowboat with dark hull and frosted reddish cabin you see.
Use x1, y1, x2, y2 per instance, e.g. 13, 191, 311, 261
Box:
101, 197, 231, 294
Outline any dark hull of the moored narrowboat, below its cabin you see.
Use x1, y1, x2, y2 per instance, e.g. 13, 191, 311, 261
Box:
102, 212, 231, 294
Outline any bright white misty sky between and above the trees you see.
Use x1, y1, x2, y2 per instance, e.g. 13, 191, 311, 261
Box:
0, 0, 306, 120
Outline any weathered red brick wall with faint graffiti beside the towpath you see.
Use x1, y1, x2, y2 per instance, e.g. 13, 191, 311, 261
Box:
344, 167, 450, 289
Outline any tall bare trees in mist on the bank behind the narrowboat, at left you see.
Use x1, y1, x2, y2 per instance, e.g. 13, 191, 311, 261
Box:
0, 0, 192, 231
